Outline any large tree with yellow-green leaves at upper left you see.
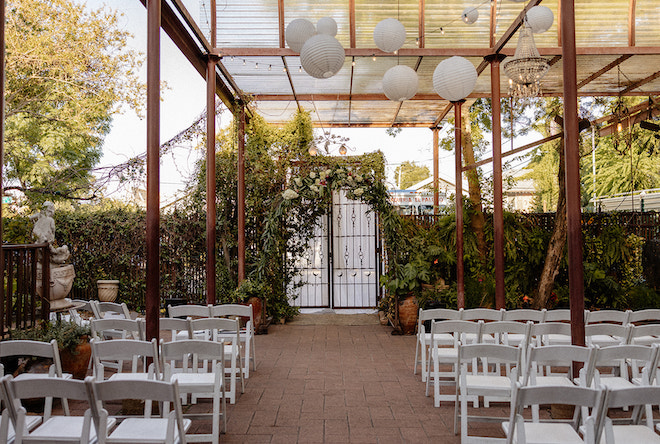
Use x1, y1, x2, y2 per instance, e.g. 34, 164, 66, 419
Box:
5, 0, 143, 202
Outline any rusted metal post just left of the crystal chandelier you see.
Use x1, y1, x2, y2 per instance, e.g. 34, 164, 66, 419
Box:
486, 54, 506, 310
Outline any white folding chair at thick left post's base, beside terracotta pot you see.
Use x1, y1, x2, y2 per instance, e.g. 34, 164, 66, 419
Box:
90, 339, 162, 381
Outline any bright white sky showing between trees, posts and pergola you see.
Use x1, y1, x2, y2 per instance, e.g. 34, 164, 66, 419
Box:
82, 0, 506, 206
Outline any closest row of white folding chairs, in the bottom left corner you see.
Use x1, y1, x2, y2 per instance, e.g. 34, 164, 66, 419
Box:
0, 376, 191, 444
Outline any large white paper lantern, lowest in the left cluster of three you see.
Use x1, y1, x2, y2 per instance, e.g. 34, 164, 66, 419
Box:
300, 34, 345, 79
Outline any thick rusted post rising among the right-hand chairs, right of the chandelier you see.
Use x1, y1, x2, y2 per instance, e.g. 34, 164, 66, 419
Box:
561, 0, 585, 345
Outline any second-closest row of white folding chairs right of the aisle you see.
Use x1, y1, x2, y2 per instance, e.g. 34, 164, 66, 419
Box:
434, 342, 660, 442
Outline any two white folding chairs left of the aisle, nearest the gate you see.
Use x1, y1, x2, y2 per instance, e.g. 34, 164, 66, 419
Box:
167, 304, 257, 378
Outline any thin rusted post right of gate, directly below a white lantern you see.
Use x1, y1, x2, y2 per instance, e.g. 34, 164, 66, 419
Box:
453, 100, 465, 308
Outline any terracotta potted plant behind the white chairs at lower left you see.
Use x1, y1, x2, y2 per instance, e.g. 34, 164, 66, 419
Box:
9, 321, 92, 379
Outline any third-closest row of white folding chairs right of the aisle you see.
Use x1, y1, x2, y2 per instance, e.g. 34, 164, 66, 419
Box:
422, 320, 655, 406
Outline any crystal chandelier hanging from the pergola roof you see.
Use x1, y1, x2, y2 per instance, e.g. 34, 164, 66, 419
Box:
502, 20, 550, 97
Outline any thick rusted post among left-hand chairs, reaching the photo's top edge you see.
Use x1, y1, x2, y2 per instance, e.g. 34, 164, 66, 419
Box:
145, 0, 161, 339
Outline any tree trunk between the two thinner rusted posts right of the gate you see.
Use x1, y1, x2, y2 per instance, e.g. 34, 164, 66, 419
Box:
461, 113, 486, 268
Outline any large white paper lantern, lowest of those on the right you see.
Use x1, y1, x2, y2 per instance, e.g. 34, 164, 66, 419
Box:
433, 56, 477, 102
